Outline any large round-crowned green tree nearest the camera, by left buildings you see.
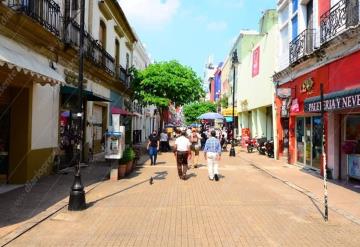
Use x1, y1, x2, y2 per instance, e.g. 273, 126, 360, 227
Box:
131, 60, 204, 124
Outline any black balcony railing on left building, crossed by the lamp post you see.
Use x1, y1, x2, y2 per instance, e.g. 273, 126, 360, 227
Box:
65, 21, 115, 75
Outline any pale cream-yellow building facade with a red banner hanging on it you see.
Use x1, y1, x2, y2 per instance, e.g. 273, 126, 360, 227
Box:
237, 10, 278, 145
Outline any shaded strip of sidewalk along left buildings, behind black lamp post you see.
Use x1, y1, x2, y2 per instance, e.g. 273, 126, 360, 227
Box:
0, 162, 110, 238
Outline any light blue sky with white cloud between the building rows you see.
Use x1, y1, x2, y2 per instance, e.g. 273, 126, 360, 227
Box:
119, 0, 276, 77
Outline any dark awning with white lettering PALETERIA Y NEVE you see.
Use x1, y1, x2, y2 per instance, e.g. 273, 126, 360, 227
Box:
304, 88, 360, 112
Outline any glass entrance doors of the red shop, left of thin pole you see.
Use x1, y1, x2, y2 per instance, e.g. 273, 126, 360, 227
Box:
296, 116, 322, 169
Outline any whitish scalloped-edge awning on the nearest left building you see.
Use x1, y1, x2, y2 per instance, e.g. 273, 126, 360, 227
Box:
0, 39, 65, 85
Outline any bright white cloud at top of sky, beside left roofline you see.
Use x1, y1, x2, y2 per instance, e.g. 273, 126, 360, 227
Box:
118, 0, 180, 28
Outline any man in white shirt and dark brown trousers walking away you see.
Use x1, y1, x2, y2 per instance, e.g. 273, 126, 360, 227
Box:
174, 131, 191, 180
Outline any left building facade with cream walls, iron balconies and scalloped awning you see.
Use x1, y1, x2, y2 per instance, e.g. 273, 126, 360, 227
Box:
0, 0, 136, 183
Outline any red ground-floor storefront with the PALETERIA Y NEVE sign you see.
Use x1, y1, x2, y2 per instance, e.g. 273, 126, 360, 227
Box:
275, 51, 360, 179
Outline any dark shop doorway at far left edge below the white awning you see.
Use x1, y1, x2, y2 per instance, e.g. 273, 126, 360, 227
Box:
0, 104, 10, 184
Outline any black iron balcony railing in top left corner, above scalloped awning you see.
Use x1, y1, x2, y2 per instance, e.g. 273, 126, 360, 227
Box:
5, 0, 61, 37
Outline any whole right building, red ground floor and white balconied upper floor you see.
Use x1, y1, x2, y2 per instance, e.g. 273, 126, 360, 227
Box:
274, 0, 360, 179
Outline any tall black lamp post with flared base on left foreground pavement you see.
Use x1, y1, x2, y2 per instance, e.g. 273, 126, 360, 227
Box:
68, 0, 86, 211
